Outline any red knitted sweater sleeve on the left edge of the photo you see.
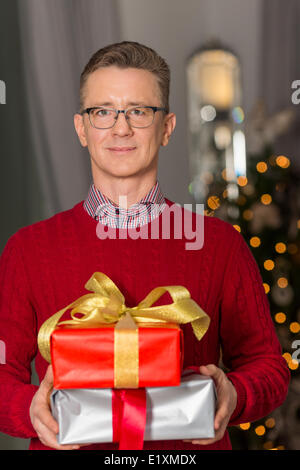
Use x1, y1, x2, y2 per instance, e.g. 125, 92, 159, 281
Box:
0, 232, 38, 438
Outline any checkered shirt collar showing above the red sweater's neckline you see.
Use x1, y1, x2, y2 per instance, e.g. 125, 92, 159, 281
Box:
83, 181, 166, 228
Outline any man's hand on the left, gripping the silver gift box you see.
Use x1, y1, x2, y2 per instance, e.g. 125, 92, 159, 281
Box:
29, 366, 80, 450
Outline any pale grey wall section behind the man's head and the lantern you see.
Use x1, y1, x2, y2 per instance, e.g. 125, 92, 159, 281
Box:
118, 0, 263, 204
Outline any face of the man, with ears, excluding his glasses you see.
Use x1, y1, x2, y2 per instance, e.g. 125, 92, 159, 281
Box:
74, 66, 175, 180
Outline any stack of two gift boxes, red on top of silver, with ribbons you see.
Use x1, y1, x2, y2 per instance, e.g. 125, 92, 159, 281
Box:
38, 273, 215, 450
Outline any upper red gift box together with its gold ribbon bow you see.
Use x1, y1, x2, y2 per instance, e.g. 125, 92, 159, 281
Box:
38, 272, 210, 389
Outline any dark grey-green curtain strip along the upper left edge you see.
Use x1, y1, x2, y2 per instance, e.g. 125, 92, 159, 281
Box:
0, 0, 43, 251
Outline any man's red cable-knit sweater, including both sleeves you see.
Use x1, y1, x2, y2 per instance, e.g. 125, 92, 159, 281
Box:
0, 199, 290, 450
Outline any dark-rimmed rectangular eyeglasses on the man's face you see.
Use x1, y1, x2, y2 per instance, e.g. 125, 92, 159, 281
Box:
81, 106, 167, 129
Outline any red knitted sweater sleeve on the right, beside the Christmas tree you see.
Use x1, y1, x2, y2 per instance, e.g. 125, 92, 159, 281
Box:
220, 229, 290, 425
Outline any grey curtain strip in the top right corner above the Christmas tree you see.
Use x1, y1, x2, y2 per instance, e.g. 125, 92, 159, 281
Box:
260, 0, 300, 175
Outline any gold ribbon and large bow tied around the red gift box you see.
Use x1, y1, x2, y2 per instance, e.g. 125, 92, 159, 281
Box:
38, 272, 210, 388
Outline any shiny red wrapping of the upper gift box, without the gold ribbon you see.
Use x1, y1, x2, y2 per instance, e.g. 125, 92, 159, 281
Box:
51, 323, 183, 389
